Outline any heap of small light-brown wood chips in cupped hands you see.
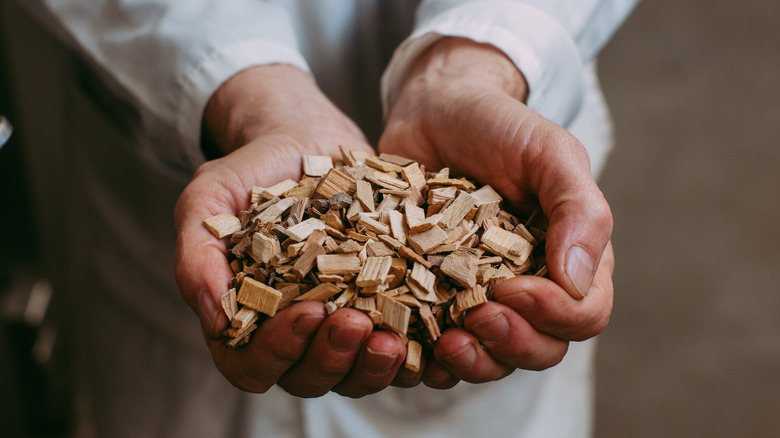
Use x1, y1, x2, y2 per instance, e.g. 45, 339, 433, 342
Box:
204, 148, 547, 371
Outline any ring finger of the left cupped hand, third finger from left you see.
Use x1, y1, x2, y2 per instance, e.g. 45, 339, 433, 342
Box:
333, 331, 406, 397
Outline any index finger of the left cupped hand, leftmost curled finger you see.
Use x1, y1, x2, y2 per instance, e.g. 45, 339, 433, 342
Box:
210, 301, 327, 393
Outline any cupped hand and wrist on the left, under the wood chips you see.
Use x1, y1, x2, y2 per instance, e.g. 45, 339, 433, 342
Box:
175, 65, 406, 397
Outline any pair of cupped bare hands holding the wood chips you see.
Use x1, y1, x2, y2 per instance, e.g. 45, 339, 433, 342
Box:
175, 38, 614, 397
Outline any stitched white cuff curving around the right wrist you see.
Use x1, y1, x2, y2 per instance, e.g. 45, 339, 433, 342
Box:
381, 1, 585, 126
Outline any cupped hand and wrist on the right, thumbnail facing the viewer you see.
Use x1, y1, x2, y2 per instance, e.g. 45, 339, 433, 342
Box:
379, 38, 614, 387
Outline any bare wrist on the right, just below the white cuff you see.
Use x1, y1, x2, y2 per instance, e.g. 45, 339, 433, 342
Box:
404, 37, 528, 102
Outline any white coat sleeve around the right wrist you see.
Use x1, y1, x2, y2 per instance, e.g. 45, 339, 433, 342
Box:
382, 0, 638, 126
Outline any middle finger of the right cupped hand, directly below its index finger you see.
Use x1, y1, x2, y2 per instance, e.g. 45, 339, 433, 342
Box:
463, 299, 571, 370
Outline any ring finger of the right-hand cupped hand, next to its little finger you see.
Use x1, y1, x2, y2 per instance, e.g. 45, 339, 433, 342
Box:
433, 328, 514, 383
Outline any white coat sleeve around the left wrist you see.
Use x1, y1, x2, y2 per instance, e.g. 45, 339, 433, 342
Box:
23, 0, 309, 165
